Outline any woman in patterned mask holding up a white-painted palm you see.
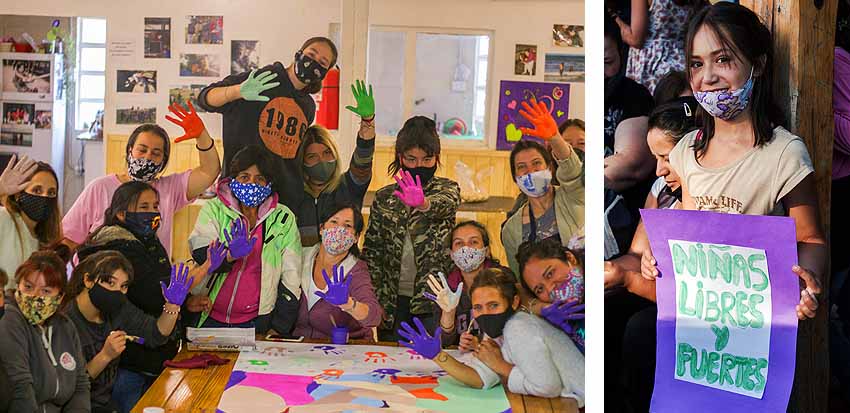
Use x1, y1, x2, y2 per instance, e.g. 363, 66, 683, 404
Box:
425, 221, 513, 351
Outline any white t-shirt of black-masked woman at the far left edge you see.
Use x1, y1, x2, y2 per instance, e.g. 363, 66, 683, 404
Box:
0, 207, 38, 289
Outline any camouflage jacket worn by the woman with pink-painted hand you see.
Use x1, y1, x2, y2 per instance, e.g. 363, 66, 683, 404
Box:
363, 176, 460, 329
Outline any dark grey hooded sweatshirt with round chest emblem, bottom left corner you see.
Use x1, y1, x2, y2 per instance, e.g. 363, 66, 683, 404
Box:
0, 297, 91, 413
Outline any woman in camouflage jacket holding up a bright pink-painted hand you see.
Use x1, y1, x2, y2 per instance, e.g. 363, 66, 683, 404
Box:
363, 116, 460, 341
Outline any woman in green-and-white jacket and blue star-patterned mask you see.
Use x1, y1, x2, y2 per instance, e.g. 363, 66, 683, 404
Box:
189, 145, 301, 334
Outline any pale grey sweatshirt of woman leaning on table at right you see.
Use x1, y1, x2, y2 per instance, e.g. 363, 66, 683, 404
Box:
468, 312, 584, 407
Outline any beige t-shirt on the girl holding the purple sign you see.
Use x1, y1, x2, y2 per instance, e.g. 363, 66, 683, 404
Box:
670, 127, 814, 215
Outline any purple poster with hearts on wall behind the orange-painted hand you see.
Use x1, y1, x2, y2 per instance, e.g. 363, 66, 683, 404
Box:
496, 80, 570, 151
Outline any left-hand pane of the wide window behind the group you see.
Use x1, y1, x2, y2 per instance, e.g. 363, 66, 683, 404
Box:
364, 30, 405, 136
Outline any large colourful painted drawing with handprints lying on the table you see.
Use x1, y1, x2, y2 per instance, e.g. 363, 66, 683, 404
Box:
218, 342, 510, 413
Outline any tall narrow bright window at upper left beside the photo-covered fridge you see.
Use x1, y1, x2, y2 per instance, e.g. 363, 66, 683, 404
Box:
74, 17, 106, 130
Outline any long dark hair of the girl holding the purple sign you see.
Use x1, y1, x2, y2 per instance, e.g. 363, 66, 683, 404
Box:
685, 2, 783, 158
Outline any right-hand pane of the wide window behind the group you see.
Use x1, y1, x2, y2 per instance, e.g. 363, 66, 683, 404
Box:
413, 33, 489, 139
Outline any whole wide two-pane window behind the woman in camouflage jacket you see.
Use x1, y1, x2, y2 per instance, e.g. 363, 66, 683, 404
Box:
366, 26, 490, 142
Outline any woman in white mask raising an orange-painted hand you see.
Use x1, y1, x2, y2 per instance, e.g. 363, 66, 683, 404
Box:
502, 100, 584, 273
